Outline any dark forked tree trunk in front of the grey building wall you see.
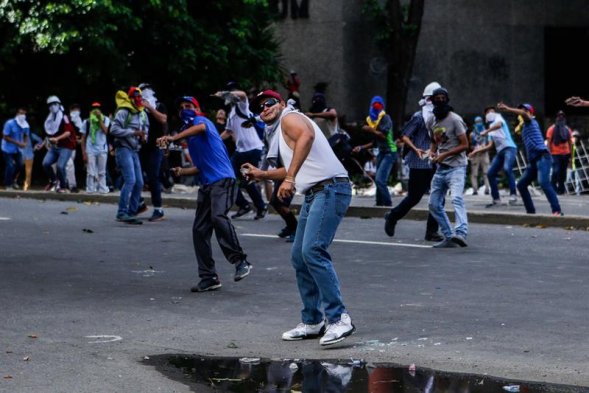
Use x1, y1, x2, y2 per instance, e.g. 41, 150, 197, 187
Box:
364, 0, 424, 132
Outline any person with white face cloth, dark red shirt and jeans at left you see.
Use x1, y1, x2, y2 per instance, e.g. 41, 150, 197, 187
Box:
43, 96, 77, 193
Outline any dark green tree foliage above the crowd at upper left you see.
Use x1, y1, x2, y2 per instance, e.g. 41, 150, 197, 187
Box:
0, 0, 282, 115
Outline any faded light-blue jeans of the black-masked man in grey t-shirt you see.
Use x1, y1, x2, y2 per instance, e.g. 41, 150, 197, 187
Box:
429, 166, 468, 238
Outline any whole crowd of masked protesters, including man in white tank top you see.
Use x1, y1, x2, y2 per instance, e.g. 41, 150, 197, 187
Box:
2, 79, 589, 345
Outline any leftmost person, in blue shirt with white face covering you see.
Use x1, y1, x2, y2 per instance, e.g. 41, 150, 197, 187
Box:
2, 108, 29, 190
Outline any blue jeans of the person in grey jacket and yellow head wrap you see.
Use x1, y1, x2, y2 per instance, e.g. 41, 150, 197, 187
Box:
115, 147, 143, 217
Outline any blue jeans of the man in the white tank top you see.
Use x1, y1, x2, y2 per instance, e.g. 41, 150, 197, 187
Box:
291, 183, 352, 325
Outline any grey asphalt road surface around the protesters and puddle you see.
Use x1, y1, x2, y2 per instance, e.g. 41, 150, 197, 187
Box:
0, 198, 589, 392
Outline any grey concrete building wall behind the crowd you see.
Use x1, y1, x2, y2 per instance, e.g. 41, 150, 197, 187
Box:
277, 0, 589, 125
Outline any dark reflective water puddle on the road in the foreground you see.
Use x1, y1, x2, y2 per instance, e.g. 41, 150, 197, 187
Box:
143, 355, 589, 393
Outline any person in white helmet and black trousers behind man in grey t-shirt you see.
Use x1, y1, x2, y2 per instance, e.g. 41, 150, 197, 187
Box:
384, 82, 443, 241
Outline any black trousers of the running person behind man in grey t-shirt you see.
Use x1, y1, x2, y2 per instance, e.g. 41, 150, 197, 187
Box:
389, 168, 438, 233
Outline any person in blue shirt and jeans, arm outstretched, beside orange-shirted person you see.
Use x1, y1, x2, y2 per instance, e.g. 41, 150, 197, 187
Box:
497, 102, 563, 216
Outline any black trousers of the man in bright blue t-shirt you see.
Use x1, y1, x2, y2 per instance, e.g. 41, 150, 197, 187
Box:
192, 179, 246, 279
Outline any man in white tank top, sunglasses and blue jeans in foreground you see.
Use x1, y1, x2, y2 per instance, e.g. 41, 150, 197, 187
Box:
243, 90, 355, 346
